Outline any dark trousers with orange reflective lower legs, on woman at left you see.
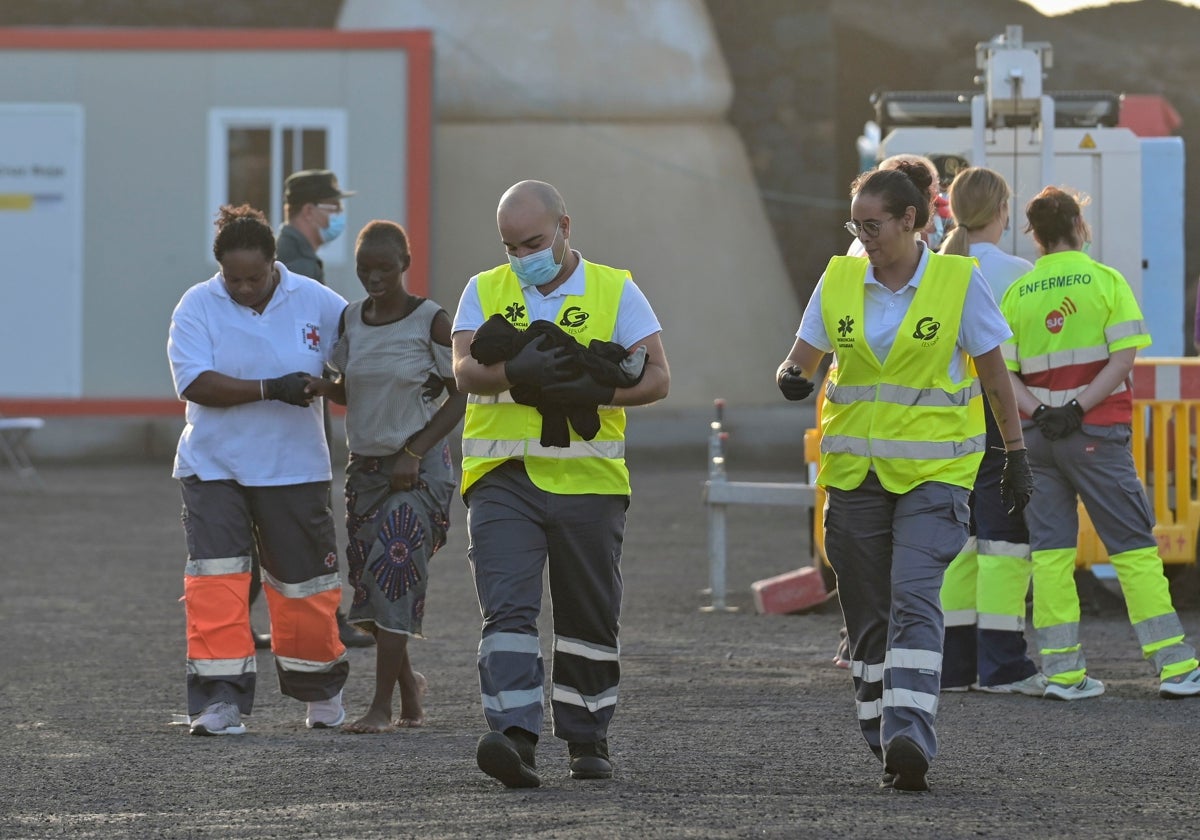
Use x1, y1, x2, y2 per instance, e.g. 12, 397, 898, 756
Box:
180, 478, 349, 714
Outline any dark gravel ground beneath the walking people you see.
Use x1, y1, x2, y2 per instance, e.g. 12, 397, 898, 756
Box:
0, 457, 1200, 840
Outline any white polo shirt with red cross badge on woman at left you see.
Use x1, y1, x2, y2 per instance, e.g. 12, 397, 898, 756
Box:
167, 262, 346, 487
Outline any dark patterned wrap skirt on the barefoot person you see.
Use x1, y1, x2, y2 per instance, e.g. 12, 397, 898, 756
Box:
346, 440, 457, 636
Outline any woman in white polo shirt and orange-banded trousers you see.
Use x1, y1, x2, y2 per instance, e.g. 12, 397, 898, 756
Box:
167, 205, 349, 734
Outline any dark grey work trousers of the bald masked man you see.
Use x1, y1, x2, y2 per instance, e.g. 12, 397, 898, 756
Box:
466, 461, 629, 742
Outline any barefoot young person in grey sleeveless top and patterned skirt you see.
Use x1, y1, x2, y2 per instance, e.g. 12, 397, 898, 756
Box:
316, 221, 466, 733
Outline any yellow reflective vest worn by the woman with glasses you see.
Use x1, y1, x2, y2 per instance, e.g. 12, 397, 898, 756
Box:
817, 253, 985, 493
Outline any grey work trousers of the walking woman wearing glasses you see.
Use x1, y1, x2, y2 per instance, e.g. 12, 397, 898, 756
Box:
824, 472, 971, 758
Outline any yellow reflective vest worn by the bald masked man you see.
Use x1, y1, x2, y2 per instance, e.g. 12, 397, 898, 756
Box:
462, 260, 630, 496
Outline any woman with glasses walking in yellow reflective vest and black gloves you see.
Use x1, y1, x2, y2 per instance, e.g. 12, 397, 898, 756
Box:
776, 164, 1033, 791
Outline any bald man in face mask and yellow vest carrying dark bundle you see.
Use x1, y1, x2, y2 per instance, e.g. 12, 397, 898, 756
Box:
452, 181, 671, 787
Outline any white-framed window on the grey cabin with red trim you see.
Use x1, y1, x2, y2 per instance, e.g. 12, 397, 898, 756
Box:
204, 108, 350, 265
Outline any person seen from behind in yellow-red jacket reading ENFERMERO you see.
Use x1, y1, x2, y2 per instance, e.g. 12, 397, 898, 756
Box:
1001, 187, 1200, 700
